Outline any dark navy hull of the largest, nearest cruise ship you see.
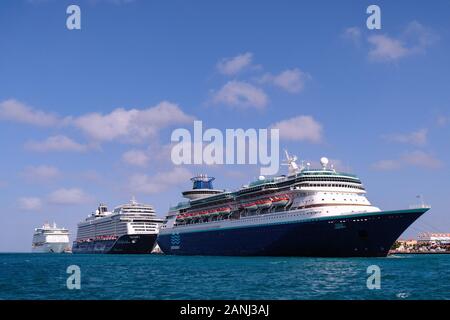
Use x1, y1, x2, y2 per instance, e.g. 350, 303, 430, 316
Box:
157, 208, 428, 257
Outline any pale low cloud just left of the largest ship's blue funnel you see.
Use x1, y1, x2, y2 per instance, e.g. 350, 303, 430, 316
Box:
129, 167, 192, 194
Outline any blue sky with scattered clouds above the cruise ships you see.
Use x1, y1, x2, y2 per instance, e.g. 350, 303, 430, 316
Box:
0, 0, 450, 251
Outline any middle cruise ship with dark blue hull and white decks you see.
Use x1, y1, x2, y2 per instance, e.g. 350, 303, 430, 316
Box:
72, 198, 163, 254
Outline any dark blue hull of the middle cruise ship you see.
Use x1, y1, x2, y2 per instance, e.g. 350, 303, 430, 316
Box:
72, 234, 157, 254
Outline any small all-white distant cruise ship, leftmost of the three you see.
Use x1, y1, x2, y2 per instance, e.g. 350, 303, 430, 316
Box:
31, 223, 69, 253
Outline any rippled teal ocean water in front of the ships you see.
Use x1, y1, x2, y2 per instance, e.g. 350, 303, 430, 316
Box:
0, 254, 450, 300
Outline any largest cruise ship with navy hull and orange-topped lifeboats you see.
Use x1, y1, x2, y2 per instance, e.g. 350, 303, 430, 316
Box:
157, 152, 429, 257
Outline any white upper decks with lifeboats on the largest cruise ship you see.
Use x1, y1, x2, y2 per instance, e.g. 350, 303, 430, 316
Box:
161, 152, 380, 233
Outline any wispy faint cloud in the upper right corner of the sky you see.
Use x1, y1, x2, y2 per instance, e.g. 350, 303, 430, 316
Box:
367, 21, 438, 62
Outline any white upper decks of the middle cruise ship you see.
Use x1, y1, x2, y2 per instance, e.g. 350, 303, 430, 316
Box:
76, 198, 162, 242
